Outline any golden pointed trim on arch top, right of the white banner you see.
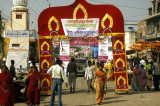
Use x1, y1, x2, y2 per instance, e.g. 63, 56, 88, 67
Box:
101, 13, 113, 29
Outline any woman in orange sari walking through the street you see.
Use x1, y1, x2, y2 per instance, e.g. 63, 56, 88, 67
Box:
93, 64, 107, 105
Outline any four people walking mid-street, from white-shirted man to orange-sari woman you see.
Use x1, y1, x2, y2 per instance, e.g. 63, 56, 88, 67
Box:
47, 58, 107, 106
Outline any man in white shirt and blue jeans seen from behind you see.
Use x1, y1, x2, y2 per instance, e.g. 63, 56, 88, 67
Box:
47, 59, 68, 106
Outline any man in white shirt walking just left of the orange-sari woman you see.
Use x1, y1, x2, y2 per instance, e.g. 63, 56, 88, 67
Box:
84, 61, 95, 93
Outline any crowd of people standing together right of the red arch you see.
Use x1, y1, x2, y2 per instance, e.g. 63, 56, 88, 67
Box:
131, 59, 160, 91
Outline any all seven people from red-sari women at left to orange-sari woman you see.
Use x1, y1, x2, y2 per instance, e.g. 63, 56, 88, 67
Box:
0, 58, 114, 106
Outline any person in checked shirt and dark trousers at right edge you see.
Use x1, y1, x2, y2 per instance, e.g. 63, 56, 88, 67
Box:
153, 59, 160, 91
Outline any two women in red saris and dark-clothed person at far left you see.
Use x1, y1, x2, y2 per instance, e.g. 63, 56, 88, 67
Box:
0, 60, 40, 106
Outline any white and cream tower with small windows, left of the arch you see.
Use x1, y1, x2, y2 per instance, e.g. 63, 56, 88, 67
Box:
4, 0, 29, 69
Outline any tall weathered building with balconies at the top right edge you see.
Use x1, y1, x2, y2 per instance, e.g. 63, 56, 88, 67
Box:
143, 0, 160, 42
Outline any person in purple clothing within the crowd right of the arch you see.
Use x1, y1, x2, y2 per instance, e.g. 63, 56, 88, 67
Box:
141, 65, 147, 90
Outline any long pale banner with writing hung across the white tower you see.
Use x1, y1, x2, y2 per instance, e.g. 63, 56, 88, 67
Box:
5, 30, 29, 38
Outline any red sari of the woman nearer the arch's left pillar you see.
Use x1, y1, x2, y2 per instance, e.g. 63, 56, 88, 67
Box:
27, 73, 40, 105
